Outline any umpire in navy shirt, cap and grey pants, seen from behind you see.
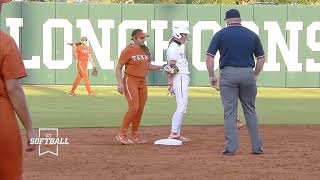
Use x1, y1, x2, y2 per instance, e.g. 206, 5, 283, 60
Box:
206, 9, 265, 155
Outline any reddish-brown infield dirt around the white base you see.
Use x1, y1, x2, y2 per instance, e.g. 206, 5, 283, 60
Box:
24, 125, 320, 180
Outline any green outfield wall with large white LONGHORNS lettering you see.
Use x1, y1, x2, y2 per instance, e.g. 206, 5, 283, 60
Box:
0, 2, 320, 87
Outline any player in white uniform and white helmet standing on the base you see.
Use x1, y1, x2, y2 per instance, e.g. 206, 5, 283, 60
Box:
167, 25, 190, 142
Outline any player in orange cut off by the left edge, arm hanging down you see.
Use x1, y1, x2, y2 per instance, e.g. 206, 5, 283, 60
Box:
0, 0, 36, 180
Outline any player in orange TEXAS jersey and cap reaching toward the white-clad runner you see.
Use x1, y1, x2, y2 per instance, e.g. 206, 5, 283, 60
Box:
116, 29, 163, 144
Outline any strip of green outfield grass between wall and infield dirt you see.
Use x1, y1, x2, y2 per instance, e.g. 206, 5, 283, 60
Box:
24, 86, 320, 128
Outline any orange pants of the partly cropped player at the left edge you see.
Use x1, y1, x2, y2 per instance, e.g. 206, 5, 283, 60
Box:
0, 102, 22, 180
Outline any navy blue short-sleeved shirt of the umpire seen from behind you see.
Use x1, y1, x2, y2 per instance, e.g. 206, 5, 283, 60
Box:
207, 23, 264, 69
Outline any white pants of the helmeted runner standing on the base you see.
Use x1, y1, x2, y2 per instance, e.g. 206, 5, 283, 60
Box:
171, 74, 190, 134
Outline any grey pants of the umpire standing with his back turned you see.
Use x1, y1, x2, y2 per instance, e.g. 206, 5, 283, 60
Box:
220, 66, 262, 153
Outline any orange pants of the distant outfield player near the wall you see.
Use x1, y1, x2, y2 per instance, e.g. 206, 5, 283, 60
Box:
71, 61, 92, 93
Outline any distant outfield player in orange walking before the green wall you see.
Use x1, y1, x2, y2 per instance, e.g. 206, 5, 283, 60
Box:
70, 37, 95, 96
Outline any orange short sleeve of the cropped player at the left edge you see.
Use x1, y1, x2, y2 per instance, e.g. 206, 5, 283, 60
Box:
1, 36, 27, 80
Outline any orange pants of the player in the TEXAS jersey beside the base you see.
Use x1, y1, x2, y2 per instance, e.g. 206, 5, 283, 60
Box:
120, 75, 148, 137
